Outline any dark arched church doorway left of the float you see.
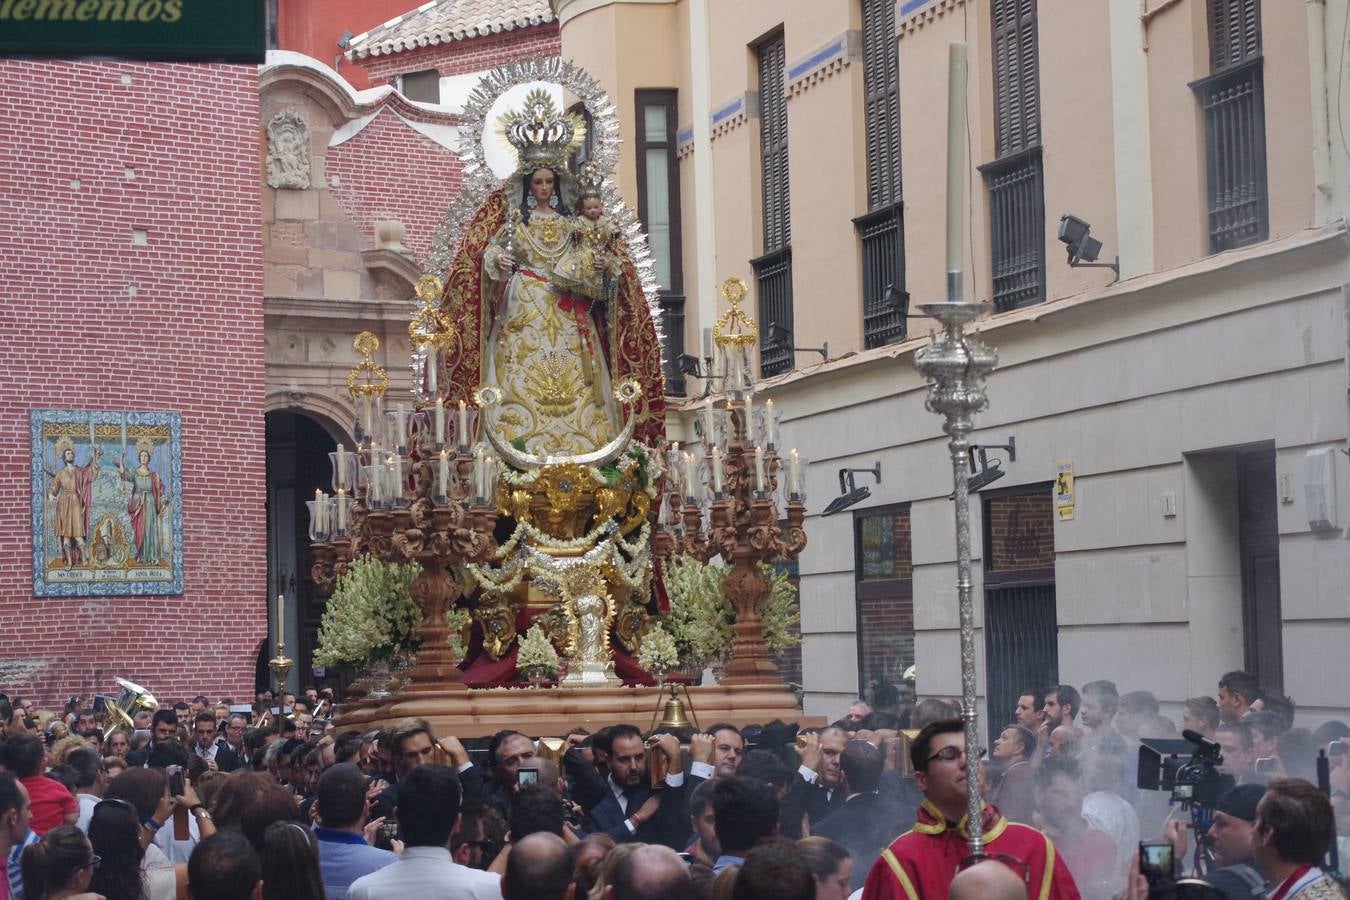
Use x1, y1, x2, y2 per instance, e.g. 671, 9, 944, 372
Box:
266, 409, 342, 694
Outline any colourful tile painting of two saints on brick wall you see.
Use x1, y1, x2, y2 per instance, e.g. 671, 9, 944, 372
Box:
30, 409, 182, 596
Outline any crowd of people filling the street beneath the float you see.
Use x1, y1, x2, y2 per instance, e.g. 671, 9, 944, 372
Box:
0, 672, 1350, 900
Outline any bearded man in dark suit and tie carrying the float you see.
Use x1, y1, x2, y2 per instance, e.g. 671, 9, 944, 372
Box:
585, 725, 701, 850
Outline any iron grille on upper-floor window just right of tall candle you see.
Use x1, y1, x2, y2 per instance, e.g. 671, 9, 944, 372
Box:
980, 147, 1045, 310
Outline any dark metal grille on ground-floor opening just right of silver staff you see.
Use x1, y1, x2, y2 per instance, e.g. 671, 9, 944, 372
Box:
984, 584, 1060, 741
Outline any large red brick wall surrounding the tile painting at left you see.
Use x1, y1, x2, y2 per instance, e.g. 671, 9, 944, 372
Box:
0, 62, 267, 703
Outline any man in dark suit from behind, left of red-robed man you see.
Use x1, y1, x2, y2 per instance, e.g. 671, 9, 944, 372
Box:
811, 741, 914, 891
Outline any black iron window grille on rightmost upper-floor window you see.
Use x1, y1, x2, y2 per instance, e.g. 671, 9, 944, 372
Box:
1191, 57, 1270, 252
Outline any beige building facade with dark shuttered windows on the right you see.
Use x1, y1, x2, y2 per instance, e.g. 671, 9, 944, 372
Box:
554, 0, 1350, 722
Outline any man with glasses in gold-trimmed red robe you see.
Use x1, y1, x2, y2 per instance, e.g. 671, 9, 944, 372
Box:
863, 719, 1079, 900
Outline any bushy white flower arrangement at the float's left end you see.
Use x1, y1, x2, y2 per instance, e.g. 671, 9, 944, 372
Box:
315, 555, 421, 667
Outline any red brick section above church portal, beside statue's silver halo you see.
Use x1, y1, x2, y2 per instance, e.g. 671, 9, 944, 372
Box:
325, 108, 464, 262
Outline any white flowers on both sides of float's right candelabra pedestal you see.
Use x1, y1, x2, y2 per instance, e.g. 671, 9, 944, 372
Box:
656, 555, 802, 671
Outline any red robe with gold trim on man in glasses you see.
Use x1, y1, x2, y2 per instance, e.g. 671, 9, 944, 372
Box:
863, 800, 1079, 900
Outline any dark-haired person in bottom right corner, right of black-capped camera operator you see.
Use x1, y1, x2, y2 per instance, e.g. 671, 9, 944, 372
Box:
1253, 779, 1346, 900
